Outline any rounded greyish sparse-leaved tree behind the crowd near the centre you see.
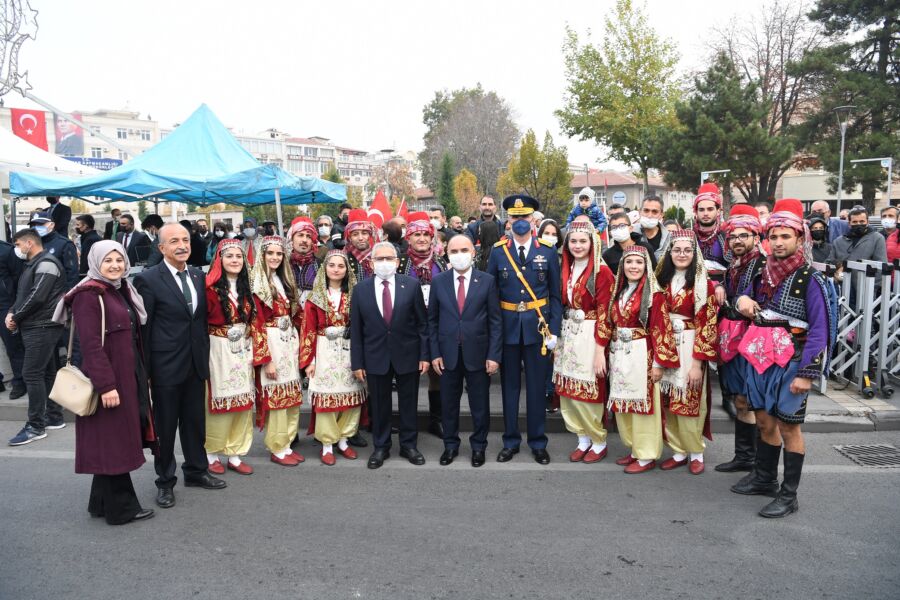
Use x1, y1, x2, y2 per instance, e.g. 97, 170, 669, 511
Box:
419, 84, 519, 195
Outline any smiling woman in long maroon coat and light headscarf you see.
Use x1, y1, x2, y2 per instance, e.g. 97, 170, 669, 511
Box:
54, 240, 156, 525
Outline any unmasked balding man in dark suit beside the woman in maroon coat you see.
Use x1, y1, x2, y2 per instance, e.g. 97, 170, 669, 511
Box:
134, 218, 225, 508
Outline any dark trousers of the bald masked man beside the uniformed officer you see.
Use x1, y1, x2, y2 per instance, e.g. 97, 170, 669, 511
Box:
441, 347, 491, 452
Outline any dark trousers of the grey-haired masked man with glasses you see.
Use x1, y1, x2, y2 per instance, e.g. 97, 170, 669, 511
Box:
366, 367, 419, 450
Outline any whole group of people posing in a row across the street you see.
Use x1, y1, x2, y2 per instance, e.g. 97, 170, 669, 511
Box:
6, 184, 892, 523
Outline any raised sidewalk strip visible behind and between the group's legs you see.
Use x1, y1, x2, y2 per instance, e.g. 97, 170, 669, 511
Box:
0, 375, 900, 433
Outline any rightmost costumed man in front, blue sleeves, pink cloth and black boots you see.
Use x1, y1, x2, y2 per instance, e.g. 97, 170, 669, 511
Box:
731, 199, 832, 518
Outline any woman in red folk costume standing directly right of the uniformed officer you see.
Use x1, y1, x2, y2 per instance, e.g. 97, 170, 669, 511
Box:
553, 221, 614, 463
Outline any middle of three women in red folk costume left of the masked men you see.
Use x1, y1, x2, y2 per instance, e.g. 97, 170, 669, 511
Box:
250, 235, 305, 467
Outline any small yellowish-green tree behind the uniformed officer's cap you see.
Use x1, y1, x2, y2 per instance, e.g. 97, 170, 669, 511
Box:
497, 129, 572, 220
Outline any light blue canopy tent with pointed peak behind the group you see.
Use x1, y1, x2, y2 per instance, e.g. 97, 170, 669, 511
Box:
9, 104, 347, 231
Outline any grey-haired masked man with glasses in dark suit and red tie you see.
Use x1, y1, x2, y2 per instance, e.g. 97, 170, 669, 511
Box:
350, 242, 429, 469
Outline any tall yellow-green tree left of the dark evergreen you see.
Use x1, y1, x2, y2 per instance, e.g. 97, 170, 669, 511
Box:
556, 0, 679, 189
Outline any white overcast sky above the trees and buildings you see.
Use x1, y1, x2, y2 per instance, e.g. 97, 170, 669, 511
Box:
17, 0, 776, 166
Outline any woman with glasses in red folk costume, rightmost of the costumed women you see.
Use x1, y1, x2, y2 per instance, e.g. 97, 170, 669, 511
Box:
656, 229, 718, 475
